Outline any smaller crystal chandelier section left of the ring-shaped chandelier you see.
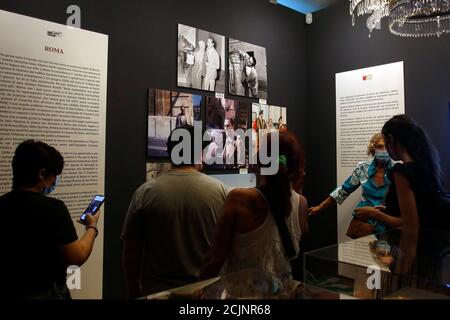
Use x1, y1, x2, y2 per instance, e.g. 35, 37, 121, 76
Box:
350, 0, 389, 38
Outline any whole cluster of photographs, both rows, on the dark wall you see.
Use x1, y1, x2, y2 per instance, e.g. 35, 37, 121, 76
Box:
147, 24, 287, 172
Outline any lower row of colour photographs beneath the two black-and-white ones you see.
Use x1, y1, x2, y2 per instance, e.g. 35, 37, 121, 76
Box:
147, 89, 287, 172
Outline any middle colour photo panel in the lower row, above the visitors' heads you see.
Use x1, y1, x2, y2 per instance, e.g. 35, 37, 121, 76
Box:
204, 97, 251, 169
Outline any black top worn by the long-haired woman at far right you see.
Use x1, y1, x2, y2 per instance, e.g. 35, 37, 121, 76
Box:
386, 162, 450, 231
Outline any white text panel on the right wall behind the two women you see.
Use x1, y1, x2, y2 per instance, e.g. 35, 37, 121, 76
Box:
336, 62, 405, 242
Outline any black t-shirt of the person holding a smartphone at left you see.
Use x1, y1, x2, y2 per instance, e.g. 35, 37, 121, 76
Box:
0, 190, 78, 297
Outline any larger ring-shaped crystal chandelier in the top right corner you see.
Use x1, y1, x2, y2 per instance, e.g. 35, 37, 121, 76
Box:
389, 0, 450, 37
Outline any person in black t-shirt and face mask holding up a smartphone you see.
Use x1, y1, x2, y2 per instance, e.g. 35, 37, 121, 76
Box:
0, 140, 99, 299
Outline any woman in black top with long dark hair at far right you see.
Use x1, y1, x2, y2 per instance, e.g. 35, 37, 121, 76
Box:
382, 115, 450, 230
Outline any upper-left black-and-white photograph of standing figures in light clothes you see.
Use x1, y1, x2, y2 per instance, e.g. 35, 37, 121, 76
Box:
177, 24, 225, 93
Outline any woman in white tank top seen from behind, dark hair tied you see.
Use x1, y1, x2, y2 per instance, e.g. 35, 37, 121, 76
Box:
200, 132, 308, 279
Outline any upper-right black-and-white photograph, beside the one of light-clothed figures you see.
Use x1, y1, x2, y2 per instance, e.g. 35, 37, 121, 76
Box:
228, 39, 267, 99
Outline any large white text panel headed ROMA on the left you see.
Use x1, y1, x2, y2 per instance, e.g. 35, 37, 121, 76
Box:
0, 10, 108, 298
